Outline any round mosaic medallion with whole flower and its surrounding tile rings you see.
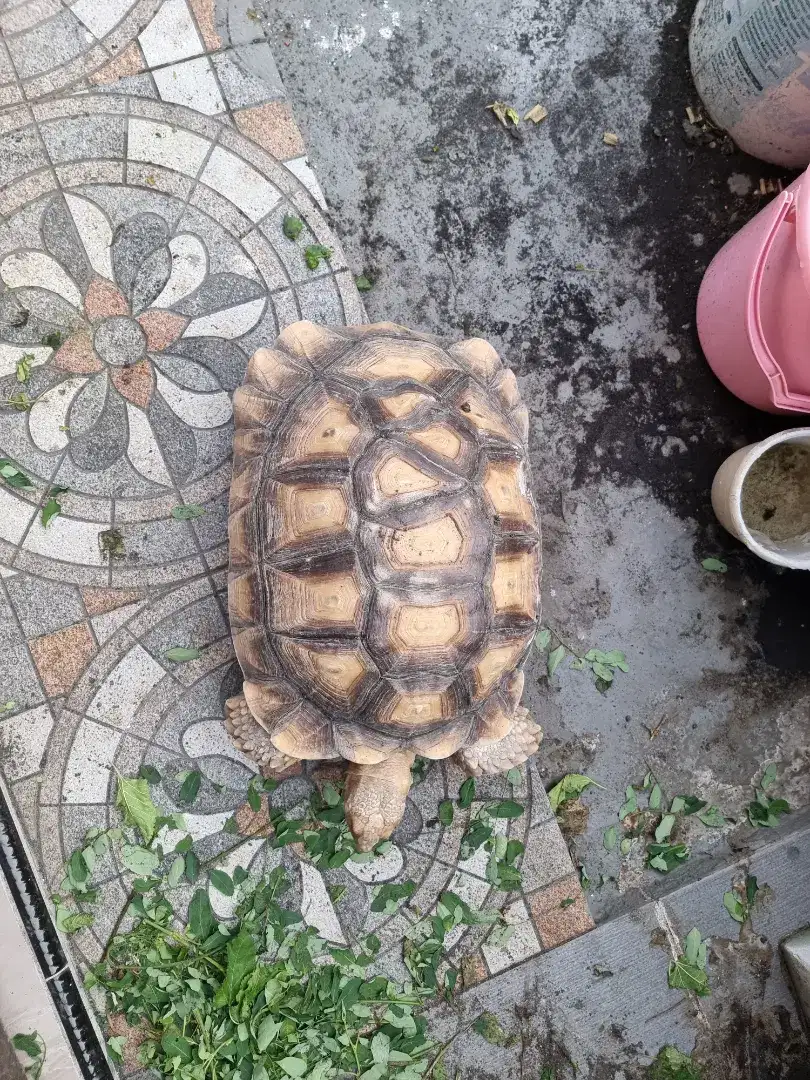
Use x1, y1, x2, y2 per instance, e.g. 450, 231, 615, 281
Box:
0, 95, 364, 586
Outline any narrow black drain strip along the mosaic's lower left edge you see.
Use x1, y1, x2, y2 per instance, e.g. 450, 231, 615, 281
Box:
0, 791, 113, 1080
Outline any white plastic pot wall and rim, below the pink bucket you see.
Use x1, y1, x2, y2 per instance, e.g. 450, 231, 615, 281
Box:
712, 428, 810, 570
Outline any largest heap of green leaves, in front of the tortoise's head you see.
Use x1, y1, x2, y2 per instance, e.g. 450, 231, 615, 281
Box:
87, 868, 434, 1080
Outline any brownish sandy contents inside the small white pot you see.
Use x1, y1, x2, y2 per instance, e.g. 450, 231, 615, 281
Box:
741, 443, 810, 541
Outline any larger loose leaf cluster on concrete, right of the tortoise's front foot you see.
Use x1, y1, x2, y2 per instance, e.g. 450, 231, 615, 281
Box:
603, 772, 726, 874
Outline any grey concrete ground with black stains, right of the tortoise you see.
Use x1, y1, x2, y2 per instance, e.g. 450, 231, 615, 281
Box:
256, 0, 810, 921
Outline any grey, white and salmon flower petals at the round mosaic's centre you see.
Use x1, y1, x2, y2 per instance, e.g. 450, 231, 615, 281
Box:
0, 193, 250, 487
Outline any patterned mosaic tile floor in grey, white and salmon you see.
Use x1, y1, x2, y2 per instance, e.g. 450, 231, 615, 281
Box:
0, 0, 592, 1036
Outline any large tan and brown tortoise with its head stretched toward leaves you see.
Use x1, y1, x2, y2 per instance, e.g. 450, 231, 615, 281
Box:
226, 322, 542, 851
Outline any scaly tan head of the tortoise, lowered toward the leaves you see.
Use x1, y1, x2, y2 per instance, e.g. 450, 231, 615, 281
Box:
343, 750, 416, 851
